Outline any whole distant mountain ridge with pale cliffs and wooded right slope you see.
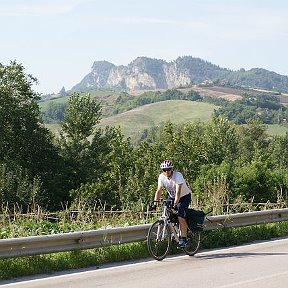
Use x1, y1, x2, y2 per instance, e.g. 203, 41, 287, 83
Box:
70, 56, 288, 92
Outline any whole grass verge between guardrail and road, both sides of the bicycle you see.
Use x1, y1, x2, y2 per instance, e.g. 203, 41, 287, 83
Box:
0, 222, 288, 280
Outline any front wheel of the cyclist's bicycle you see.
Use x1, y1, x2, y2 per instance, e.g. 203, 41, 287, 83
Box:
147, 220, 171, 261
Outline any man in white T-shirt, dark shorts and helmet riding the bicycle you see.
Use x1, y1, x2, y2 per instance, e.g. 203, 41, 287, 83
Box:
154, 160, 191, 248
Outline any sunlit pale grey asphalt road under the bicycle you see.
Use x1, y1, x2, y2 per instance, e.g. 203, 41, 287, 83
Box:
0, 238, 288, 288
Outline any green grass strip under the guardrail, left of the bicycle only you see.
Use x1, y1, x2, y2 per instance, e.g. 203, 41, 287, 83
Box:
0, 242, 148, 280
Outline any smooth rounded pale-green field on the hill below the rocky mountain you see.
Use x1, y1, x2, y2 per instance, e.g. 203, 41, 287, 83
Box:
100, 100, 217, 137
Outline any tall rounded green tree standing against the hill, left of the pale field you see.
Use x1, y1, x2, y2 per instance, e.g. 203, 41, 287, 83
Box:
60, 93, 101, 188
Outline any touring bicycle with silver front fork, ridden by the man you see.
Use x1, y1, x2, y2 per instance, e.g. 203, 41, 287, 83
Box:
147, 200, 201, 261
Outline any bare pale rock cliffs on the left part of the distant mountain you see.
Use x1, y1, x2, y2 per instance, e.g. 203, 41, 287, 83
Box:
72, 57, 204, 91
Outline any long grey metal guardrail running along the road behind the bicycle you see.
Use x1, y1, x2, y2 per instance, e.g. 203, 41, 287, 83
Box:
0, 208, 288, 259
